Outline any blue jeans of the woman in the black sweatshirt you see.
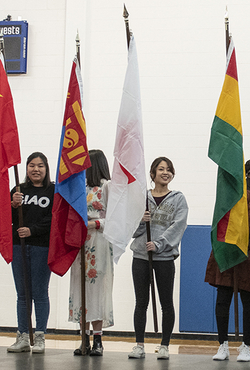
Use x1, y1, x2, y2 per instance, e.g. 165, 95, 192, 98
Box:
12, 245, 51, 333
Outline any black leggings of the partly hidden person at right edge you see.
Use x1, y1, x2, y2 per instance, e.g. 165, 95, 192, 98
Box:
215, 286, 250, 346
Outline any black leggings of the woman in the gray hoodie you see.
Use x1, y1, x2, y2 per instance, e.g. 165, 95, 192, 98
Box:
132, 258, 175, 346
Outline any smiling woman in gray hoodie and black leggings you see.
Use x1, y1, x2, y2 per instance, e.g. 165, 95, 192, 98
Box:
128, 157, 188, 359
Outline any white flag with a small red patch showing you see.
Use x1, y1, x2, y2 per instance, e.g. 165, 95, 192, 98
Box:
104, 37, 147, 263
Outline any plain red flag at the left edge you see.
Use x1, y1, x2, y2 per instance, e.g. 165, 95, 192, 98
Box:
0, 55, 21, 263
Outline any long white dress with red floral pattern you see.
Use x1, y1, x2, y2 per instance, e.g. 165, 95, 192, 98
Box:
69, 180, 114, 328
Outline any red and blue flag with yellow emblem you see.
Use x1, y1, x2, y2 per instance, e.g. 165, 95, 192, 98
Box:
48, 58, 91, 276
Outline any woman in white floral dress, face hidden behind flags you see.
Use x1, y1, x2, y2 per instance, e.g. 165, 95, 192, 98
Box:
69, 150, 114, 356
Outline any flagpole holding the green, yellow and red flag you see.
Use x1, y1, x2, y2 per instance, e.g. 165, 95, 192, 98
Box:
225, 7, 239, 341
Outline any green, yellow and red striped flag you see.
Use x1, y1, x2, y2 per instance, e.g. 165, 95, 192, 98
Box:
208, 39, 249, 272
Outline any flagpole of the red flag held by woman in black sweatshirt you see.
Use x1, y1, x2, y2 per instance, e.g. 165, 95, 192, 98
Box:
0, 30, 34, 346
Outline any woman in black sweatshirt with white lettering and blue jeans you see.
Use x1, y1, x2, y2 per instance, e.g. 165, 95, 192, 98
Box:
7, 152, 54, 353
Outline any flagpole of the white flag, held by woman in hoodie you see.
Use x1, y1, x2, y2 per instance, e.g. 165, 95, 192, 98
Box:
123, 4, 158, 333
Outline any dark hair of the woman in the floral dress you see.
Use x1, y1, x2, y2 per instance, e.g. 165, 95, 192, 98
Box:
86, 149, 110, 187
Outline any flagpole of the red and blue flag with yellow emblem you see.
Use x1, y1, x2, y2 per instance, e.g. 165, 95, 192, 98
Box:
76, 31, 86, 356
